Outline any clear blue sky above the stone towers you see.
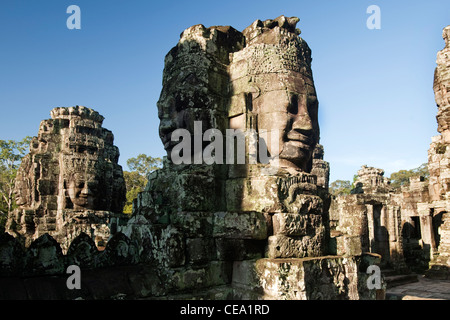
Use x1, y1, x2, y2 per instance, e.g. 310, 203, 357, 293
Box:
0, 0, 450, 181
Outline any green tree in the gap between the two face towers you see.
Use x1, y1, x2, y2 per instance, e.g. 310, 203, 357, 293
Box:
123, 154, 162, 214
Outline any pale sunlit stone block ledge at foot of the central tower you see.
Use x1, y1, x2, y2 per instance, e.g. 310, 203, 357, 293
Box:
232, 255, 385, 300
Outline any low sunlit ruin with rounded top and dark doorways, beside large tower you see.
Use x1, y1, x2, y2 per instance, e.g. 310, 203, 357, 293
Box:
330, 166, 406, 272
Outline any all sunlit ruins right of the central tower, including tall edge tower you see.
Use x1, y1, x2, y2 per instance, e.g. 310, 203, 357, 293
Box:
330, 26, 450, 279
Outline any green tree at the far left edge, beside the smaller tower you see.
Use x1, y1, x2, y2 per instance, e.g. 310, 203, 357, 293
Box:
0, 137, 31, 224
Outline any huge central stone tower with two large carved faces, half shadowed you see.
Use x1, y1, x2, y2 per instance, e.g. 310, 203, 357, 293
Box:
127, 16, 384, 299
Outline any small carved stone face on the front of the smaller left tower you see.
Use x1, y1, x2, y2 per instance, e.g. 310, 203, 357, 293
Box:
67, 173, 98, 210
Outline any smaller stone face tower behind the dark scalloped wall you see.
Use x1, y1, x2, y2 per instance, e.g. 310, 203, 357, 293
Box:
7, 106, 126, 250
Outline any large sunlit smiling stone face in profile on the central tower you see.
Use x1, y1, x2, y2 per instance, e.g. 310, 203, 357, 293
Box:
254, 72, 319, 171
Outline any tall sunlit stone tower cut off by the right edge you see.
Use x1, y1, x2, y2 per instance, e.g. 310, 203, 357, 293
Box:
428, 26, 450, 277
